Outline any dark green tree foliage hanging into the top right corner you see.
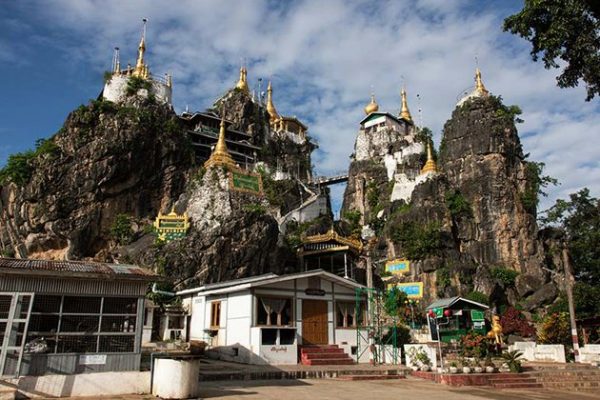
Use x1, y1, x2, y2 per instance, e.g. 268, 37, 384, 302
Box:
504, 0, 600, 101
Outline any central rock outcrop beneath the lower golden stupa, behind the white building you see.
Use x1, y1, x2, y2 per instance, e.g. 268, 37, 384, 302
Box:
129, 167, 296, 289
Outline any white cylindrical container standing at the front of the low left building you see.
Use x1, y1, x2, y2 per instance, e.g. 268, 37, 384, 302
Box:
151, 355, 200, 399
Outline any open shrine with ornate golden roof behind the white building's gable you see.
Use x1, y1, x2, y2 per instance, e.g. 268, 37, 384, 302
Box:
298, 228, 364, 281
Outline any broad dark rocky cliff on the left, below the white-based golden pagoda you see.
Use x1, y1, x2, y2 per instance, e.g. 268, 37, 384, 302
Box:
0, 99, 192, 260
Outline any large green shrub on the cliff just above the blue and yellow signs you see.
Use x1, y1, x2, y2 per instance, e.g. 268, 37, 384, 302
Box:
391, 221, 442, 260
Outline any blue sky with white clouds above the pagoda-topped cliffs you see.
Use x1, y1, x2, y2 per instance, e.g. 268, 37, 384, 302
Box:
0, 0, 600, 216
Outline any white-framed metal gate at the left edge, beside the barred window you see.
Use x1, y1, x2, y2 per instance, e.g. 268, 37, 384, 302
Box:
0, 293, 33, 377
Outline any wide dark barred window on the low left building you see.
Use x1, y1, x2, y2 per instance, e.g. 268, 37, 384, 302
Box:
25, 295, 138, 353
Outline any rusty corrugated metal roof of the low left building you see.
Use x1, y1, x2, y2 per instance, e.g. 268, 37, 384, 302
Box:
0, 257, 159, 280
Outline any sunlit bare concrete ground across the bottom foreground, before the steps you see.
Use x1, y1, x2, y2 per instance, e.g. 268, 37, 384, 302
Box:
39, 378, 600, 400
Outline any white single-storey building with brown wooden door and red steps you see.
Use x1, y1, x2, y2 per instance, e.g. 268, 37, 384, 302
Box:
177, 270, 368, 365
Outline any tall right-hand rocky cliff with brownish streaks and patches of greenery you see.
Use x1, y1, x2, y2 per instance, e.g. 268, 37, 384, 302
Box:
344, 96, 558, 310
